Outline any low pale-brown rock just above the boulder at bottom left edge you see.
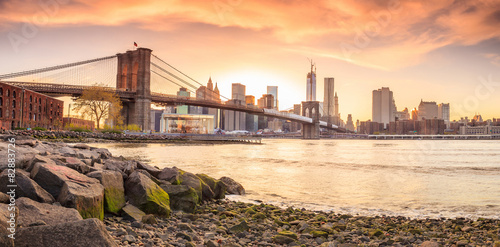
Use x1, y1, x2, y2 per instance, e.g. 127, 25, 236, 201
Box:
16, 197, 82, 227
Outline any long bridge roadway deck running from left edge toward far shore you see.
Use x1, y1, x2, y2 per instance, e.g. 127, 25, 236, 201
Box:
0, 81, 346, 132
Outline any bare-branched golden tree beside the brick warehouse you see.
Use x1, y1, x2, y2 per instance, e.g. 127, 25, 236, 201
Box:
74, 85, 123, 129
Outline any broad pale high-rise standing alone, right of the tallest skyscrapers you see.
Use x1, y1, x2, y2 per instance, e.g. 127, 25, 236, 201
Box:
372, 87, 396, 126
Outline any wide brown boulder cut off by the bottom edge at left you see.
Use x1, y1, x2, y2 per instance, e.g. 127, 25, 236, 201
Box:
15, 219, 118, 247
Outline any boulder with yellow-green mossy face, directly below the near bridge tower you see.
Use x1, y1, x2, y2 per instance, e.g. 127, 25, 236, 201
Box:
125, 172, 170, 217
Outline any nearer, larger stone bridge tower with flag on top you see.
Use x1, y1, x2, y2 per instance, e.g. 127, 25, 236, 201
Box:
116, 48, 152, 131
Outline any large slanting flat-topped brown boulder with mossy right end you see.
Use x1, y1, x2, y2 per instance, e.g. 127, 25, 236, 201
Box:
31, 163, 104, 219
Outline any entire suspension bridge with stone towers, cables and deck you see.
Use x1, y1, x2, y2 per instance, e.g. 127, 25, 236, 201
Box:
0, 48, 346, 139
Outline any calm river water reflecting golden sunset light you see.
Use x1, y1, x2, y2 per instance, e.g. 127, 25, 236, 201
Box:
93, 139, 500, 219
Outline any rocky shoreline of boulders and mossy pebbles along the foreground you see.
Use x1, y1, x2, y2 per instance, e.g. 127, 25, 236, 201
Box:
0, 135, 500, 247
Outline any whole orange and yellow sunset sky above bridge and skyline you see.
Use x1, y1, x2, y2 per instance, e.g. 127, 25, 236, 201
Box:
0, 0, 500, 121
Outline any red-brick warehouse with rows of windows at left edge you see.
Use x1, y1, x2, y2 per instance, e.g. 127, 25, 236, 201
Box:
0, 82, 64, 129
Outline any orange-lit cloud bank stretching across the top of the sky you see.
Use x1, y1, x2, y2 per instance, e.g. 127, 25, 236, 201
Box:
0, 0, 500, 70
